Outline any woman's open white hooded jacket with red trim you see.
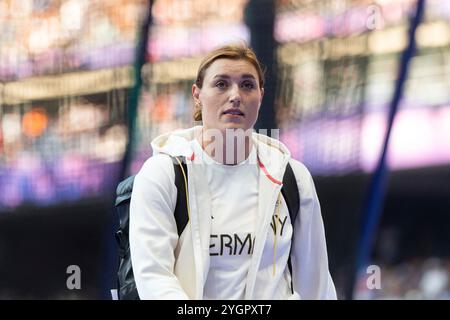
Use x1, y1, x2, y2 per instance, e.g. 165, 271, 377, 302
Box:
129, 127, 336, 300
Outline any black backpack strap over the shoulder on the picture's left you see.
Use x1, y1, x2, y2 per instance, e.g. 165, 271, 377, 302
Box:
172, 157, 189, 236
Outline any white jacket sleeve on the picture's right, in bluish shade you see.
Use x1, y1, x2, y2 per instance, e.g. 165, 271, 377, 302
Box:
290, 161, 337, 300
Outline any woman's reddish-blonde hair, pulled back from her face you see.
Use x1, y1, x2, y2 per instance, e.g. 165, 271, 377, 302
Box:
194, 44, 265, 121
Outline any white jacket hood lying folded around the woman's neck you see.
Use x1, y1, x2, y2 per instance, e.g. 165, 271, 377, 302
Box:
151, 126, 291, 182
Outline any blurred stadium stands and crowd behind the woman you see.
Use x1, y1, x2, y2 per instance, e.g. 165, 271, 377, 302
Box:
0, 0, 450, 299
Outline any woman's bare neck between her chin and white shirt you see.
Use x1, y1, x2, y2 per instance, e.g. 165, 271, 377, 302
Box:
196, 128, 253, 165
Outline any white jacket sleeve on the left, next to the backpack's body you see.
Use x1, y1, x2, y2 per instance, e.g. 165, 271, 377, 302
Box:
129, 155, 189, 300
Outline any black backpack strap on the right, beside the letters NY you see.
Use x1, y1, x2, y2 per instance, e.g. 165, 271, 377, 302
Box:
281, 162, 300, 293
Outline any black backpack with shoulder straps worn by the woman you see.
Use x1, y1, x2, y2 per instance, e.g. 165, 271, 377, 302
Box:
115, 157, 300, 300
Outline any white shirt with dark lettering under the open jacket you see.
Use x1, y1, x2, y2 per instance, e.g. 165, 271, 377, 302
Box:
192, 140, 259, 300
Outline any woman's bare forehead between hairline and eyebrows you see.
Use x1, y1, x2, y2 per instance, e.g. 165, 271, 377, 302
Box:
205, 59, 258, 79
